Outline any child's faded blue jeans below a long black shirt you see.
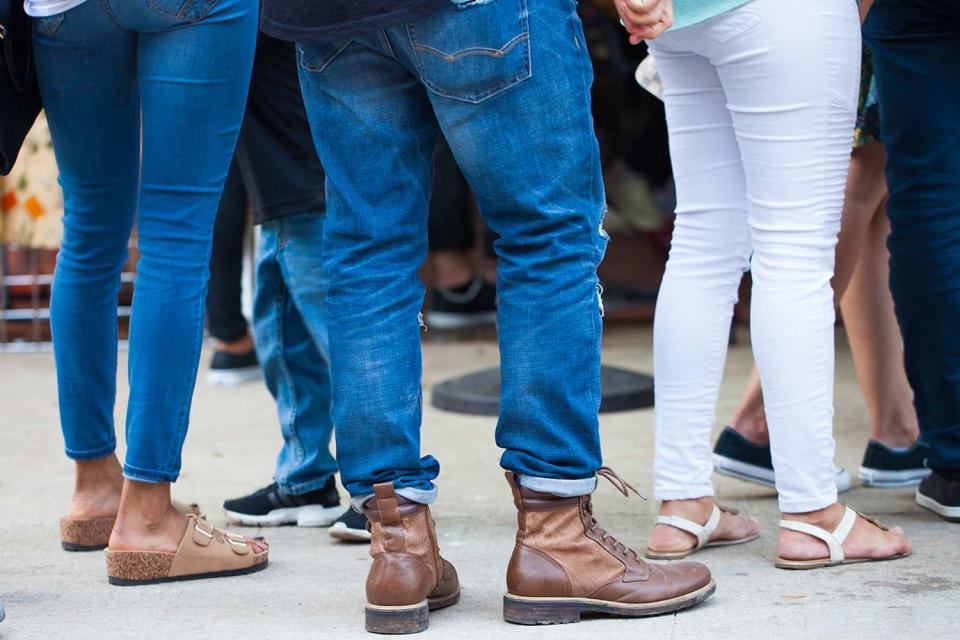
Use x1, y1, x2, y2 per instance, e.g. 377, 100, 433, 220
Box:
253, 213, 337, 494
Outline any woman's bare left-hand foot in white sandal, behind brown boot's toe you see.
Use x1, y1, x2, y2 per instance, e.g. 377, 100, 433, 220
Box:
647, 497, 760, 552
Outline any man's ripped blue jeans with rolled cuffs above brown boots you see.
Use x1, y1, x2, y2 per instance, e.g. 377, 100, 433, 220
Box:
299, 0, 607, 502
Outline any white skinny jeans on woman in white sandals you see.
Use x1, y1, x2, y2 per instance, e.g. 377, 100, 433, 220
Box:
650, 0, 860, 513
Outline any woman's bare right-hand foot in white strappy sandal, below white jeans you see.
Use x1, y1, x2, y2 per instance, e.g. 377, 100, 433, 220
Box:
777, 502, 911, 560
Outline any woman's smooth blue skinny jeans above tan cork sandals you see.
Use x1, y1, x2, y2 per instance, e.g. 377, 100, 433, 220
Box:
34, 0, 258, 482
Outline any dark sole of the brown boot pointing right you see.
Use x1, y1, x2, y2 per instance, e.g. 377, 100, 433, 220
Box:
503, 581, 717, 625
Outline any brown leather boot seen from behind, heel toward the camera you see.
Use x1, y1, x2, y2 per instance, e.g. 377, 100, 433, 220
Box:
363, 482, 460, 633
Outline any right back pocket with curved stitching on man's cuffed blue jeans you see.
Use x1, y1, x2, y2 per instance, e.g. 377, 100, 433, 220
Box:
407, 0, 532, 103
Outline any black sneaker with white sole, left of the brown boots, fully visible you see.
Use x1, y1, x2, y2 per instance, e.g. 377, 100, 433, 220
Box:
223, 476, 343, 527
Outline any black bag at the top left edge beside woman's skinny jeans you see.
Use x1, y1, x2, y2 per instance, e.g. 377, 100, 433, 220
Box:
0, 0, 41, 176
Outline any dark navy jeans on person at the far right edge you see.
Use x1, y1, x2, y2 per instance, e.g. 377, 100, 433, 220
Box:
864, 0, 960, 473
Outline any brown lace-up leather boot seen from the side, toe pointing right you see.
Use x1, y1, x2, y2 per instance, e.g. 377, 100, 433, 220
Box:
503, 467, 716, 624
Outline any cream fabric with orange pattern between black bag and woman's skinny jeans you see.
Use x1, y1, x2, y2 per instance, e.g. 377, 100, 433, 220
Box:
0, 114, 63, 249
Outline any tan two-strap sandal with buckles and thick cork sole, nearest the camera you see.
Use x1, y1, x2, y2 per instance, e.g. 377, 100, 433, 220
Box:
106, 515, 269, 586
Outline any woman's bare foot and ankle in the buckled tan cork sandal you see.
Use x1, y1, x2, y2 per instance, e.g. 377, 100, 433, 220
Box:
110, 480, 267, 553
